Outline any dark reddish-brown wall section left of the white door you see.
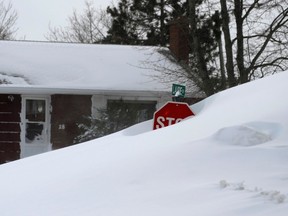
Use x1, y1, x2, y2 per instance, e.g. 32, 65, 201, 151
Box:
0, 94, 21, 163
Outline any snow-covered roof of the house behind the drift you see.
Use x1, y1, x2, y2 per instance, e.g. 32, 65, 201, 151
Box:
0, 41, 187, 93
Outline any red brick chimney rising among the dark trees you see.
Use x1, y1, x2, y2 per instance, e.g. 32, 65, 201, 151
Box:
169, 17, 189, 63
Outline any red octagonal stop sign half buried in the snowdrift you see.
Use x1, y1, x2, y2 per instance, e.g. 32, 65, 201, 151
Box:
153, 102, 195, 130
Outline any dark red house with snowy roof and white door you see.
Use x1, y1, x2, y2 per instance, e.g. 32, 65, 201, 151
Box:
0, 37, 202, 163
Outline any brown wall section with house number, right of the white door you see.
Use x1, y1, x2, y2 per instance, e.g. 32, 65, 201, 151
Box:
51, 95, 92, 149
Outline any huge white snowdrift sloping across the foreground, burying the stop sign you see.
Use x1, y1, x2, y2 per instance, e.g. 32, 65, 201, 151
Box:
0, 72, 288, 216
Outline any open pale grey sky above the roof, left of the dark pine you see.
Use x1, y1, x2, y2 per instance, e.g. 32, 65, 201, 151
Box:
10, 0, 113, 40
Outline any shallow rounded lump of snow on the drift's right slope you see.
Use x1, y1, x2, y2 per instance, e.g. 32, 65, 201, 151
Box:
214, 122, 280, 146
